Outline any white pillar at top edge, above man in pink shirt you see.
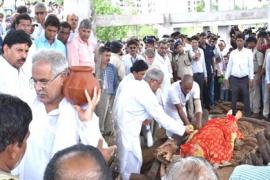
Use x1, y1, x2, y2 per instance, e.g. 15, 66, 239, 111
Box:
64, 0, 92, 20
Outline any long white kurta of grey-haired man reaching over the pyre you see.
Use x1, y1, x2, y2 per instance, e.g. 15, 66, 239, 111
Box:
114, 80, 185, 168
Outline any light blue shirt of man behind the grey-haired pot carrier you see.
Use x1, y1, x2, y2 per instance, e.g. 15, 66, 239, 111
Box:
35, 32, 66, 57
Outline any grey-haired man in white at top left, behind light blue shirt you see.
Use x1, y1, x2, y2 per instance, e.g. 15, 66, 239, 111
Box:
32, 3, 47, 39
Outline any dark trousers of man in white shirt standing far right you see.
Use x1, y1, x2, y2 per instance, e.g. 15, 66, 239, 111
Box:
230, 76, 251, 116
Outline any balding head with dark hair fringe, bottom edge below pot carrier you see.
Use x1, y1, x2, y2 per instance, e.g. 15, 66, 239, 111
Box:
44, 144, 112, 180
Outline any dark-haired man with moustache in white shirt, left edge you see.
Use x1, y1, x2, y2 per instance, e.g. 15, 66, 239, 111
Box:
0, 30, 32, 102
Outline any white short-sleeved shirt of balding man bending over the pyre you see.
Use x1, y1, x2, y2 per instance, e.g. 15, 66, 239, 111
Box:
165, 81, 200, 124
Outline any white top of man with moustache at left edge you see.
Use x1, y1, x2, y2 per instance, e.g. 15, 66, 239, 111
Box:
0, 56, 35, 102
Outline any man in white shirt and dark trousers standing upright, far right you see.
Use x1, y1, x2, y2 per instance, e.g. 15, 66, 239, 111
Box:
224, 34, 254, 116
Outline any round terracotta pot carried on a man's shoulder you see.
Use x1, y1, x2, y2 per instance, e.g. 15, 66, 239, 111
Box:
63, 66, 99, 105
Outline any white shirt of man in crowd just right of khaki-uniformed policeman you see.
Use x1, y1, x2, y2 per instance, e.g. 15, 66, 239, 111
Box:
190, 48, 207, 77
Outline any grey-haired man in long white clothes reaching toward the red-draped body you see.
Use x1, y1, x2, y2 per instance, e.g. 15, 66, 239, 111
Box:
114, 68, 192, 180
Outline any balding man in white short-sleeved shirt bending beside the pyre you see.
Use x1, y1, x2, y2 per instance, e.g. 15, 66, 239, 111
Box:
165, 74, 202, 135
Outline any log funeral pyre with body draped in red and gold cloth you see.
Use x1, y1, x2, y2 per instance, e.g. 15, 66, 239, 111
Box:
144, 106, 270, 179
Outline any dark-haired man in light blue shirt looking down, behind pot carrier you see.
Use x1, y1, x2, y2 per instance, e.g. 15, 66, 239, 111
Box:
35, 14, 66, 56
